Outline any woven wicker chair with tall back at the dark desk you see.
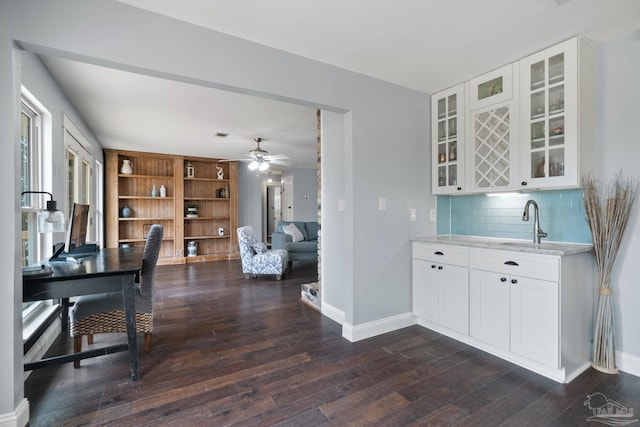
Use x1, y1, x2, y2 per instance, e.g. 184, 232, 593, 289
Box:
69, 224, 163, 368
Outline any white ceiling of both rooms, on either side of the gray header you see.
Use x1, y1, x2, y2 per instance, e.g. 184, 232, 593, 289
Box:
43, 0, 640, 168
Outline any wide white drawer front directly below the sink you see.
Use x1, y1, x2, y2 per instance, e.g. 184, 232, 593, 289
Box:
469, 249, 560, 282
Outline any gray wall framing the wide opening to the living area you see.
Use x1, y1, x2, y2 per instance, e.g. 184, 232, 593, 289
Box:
0, 5, 434, 422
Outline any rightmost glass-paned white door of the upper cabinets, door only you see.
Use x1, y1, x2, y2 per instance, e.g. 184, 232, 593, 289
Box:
520, 39, 578, 188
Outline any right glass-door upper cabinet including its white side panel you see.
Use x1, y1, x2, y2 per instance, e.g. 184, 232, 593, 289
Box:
519, 38, 595, 188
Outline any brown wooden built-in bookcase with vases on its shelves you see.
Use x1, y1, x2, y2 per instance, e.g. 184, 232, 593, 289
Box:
105, 150, 239, 264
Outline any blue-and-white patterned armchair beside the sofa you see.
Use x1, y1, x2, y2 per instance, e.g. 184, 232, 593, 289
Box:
238, 225, 288, 280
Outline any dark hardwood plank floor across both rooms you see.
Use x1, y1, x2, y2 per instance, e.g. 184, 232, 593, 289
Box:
25, 261, 640, 426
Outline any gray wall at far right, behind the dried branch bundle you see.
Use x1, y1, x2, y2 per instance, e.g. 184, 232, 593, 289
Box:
596, 31, 640, 362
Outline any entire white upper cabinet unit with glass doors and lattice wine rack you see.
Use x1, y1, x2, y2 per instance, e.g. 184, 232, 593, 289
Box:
432, 38, 595, 194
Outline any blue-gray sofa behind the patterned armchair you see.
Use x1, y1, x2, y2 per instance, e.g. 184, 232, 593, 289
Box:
271, 221, 320, 268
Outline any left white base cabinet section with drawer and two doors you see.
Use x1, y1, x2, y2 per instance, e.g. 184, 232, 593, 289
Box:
413, 242, 469, 335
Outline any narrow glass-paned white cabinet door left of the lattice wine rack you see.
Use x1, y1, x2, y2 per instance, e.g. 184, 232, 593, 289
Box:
431, 84, 464, 194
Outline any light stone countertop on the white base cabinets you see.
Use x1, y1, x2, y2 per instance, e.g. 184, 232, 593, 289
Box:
411, 234, 593, 256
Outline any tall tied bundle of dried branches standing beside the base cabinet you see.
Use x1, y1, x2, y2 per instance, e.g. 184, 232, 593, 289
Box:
582, 173, 638, 374
